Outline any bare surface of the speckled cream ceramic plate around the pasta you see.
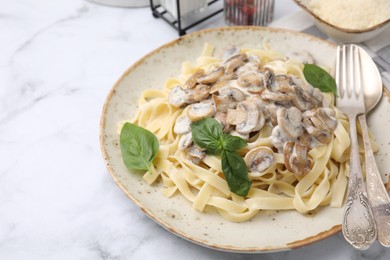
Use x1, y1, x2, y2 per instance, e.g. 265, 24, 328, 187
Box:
101, 27, 390, 252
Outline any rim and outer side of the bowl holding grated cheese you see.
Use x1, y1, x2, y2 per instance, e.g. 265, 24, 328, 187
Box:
294, 0, 390, 43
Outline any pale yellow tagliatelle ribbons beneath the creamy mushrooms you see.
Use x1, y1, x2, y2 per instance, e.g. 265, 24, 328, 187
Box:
120, 44, 376, 222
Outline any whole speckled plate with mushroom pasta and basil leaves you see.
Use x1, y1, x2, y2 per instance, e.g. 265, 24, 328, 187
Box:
100, 27, 390, 252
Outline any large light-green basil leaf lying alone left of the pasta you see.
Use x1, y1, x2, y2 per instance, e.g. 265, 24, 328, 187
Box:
120, 123, 159, 172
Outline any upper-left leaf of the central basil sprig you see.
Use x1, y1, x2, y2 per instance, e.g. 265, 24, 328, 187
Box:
191, 118, 223, 155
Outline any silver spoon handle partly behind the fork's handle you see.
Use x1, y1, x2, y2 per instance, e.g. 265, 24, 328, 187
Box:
359, 114, 390, 247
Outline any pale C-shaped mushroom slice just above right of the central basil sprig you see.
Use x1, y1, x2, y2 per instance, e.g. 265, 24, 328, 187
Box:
236, 100, 259, 134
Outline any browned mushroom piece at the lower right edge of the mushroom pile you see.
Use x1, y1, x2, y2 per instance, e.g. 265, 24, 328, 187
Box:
283, 142, 311, 176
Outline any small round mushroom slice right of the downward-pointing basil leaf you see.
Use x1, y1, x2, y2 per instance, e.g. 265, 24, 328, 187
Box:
244, 146, 275, 173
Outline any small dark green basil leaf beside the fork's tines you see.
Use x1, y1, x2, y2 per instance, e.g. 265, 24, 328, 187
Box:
303, 64, 337, 95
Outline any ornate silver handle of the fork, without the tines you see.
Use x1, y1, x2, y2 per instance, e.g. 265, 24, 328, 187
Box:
342, 114, 377, 249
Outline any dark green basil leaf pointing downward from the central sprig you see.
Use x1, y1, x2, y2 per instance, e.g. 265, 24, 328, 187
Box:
221, 150, 251, 197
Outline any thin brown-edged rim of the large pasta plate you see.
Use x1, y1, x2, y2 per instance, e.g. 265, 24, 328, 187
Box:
99, 26, 341, 253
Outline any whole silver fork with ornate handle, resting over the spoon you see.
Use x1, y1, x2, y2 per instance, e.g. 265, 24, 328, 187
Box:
336, 44, 377, 249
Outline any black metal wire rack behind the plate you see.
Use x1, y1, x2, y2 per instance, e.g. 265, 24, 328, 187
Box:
150, 0, 223, 36
